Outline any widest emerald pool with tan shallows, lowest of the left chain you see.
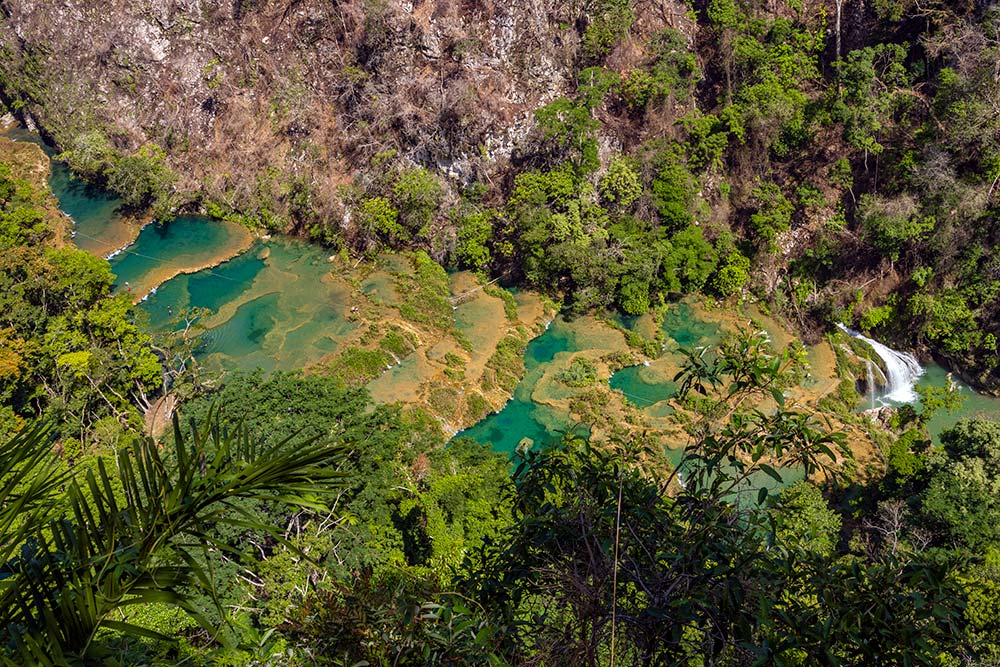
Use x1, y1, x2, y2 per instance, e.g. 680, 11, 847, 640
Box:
140, 239, 355, 372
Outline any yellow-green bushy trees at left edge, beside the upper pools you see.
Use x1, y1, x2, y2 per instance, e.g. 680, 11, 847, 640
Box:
0, 168, 163, 443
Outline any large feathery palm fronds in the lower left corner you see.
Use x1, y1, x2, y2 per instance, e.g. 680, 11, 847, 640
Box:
0, 416, 346, 665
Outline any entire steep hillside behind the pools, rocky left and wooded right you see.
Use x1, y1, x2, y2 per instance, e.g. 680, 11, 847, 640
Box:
0, 0, 1000, 386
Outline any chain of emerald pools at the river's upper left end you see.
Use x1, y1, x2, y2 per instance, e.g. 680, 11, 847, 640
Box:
5, 127, 354, 371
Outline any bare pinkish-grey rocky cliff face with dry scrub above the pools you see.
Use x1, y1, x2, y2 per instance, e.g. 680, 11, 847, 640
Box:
0, 0, 685, 226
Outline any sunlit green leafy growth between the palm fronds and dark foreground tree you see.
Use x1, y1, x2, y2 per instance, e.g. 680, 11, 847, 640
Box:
189, 374, 523, 667
